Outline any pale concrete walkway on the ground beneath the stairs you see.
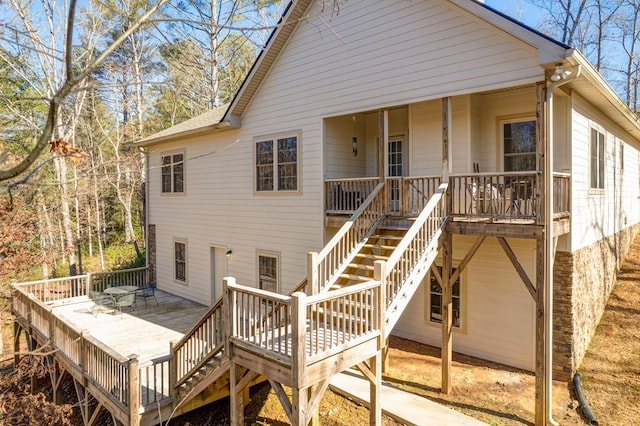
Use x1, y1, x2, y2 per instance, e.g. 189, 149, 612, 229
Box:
329, 370, 486, 426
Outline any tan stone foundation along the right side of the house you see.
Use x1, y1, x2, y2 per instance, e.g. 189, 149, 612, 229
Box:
553, 225, 640, 381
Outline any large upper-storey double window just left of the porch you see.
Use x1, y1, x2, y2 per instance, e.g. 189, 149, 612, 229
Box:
255, 135, 299, 192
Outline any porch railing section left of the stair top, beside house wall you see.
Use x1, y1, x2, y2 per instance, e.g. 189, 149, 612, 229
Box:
324, 177, 379, 214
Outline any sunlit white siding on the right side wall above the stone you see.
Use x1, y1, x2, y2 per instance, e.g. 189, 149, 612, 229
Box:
571, 95, 640, 251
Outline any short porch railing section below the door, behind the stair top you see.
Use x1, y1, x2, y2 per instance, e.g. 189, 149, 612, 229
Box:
385, 176, 441, 217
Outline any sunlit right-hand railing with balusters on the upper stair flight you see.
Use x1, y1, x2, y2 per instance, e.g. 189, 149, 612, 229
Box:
381, 183, 448, 337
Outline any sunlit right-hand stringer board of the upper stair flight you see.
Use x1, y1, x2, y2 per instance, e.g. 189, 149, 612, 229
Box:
384, 226, 446, 339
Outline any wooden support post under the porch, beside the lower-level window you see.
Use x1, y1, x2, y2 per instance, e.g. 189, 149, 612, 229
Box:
441, 233, 453, 395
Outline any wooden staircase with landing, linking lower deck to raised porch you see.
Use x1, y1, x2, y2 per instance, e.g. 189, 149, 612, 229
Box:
170, 184, 447, 424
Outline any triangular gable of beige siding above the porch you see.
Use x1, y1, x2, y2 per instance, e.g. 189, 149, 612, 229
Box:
245, 0, 542, 125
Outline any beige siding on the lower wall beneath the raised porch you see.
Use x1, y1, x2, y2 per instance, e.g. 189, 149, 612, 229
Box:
392, 236, 535, 371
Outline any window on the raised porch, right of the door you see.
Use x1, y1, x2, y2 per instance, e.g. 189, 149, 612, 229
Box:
502, 120, 536, 172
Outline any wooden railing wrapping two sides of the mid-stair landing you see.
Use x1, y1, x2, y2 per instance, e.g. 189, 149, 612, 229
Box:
223, 278, 384, 368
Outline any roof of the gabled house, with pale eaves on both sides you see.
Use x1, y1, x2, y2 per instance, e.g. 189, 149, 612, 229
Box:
139, 0, 640, 145
